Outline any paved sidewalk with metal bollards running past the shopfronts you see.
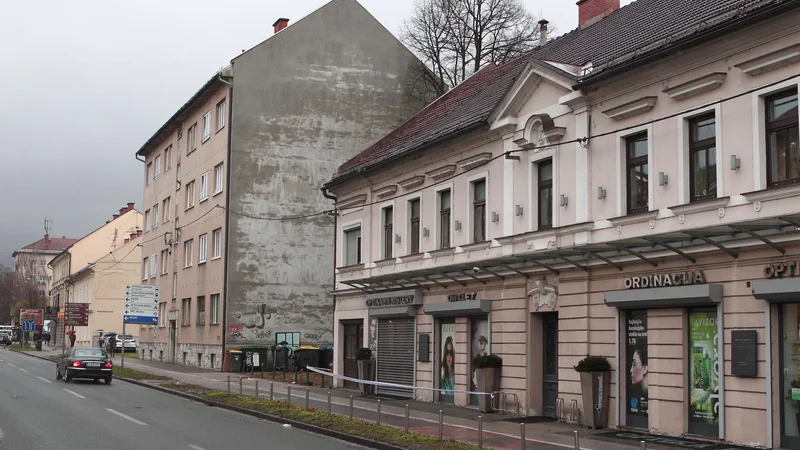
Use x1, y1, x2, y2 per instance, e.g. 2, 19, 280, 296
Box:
15, 347, 708, 450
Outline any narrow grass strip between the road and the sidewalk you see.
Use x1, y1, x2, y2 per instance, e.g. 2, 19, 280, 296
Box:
161, 382, 478, 450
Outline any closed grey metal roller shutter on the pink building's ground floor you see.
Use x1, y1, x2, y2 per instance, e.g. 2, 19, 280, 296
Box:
377, 319, 414, 398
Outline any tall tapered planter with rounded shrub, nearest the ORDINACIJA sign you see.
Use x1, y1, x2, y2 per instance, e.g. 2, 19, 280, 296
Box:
575, 355, 611, 428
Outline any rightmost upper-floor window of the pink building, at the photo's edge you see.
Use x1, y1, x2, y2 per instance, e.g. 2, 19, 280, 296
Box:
765, 89, 800, 187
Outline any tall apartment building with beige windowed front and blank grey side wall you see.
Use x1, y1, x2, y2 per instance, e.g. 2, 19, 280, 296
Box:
137, 0, 434, 368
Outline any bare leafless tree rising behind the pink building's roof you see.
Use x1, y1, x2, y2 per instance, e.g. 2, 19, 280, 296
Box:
400, 0, 539, 96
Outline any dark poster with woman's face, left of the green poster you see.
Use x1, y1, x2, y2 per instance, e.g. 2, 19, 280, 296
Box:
625, 311, 649, 428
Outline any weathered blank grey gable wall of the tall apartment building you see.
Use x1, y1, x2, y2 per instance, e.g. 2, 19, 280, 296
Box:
226, 0, 432, 348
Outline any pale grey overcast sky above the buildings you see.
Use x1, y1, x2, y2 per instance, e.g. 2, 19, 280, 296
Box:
0, 0, 631, 264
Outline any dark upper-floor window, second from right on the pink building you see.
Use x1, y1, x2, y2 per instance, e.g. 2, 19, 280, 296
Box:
689, 113, 717, 202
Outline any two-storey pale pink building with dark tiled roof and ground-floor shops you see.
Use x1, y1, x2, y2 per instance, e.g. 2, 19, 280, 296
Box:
326, 0, 800, 448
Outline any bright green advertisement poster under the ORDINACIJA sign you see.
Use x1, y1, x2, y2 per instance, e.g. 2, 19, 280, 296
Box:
689, 311, 720, 436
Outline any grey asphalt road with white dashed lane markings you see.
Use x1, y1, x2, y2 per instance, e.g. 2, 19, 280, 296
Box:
0, 349, 363, 450
